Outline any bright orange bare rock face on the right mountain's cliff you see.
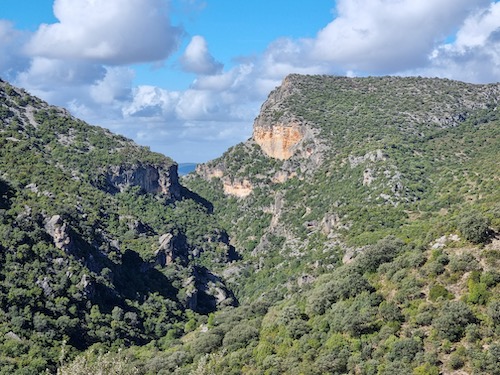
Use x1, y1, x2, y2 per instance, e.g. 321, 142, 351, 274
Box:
253, 122, 303, 160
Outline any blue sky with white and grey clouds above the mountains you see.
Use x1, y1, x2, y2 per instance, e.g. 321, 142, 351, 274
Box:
0, 0, 500, 162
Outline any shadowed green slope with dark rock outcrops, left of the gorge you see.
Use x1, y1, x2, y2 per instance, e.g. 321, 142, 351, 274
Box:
0, 81, 237, 373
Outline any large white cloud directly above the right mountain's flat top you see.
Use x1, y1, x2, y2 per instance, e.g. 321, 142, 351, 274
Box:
311, 0, 489, 74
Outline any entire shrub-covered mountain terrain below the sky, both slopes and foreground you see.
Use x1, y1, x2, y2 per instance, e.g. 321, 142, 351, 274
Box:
0, 75, 500, 374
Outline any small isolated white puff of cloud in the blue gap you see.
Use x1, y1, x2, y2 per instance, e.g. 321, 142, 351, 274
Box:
180, 35, 224, 74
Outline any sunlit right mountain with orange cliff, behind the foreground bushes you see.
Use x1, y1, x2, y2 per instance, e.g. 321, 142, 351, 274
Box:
186, 75, 500, 296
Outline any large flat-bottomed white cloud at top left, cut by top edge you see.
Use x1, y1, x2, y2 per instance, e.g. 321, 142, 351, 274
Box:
26, 0, 182, 64
